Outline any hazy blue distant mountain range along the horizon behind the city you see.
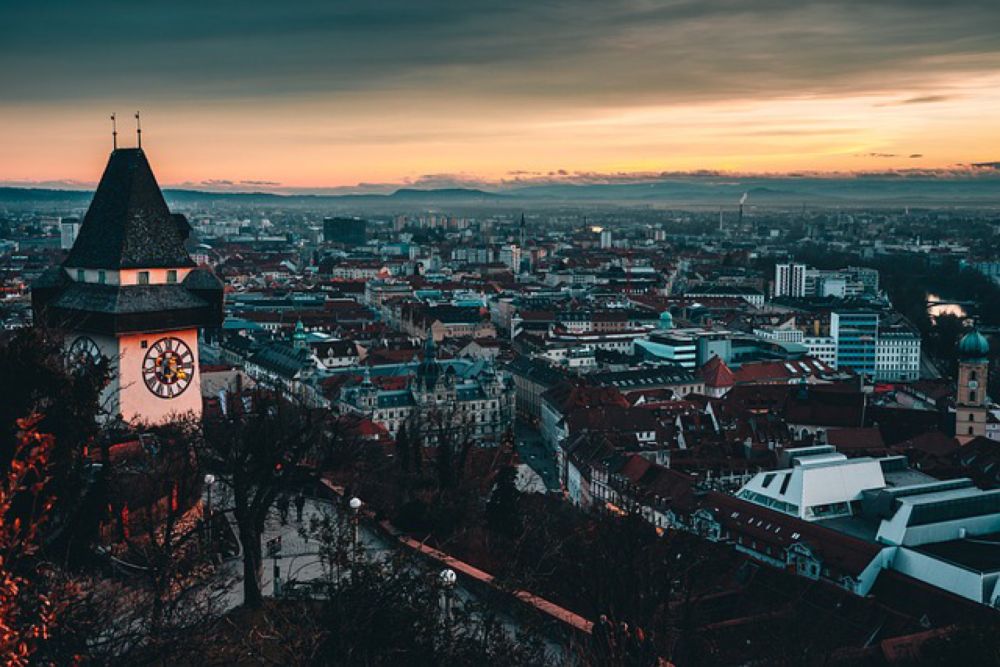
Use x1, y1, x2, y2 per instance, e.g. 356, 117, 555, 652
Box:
0, 177, 1000, 206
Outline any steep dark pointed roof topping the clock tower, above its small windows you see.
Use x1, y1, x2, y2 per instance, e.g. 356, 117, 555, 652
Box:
63, 148, 194, 270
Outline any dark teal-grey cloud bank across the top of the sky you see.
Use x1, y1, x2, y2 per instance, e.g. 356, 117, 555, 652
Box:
0, 0, 1000, 105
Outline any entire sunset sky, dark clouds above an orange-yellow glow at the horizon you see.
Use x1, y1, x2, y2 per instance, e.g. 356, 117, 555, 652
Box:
0, 0, 1000, 189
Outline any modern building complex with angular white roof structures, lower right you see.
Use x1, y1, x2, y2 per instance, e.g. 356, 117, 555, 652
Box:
720, 446, 1000, 607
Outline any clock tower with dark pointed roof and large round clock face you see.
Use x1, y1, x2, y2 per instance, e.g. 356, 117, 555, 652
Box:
32, 148, 223, 423
